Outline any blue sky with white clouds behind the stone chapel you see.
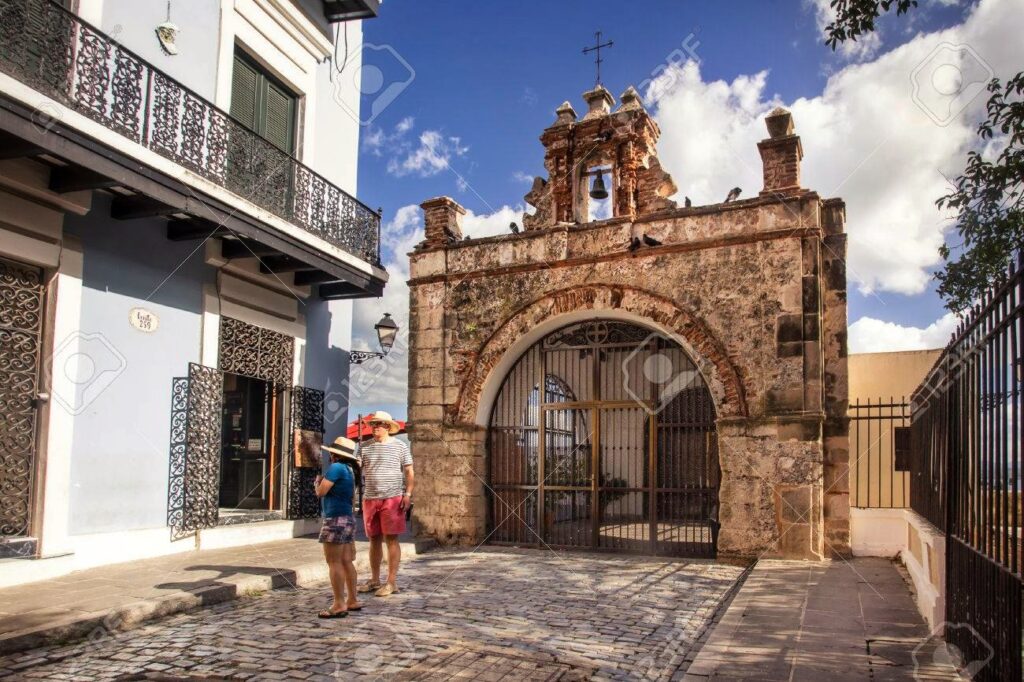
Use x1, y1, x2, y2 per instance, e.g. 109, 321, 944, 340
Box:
350, 0, 1024, 413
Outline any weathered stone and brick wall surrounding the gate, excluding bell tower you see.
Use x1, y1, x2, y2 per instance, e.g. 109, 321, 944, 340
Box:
409, 91, 849, 559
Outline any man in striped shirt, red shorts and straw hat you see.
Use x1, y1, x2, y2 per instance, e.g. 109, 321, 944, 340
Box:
359, 411, 413, 597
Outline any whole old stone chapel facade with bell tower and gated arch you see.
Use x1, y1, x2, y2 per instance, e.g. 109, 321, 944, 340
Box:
409, 86, 850, 559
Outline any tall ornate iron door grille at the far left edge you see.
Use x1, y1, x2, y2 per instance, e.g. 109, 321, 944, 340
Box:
0, 254, 43, 540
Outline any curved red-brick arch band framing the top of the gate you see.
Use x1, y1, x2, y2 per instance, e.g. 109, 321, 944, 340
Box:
454, 285, 748, 426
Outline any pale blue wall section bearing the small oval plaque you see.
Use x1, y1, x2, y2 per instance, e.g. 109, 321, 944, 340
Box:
64, 193, 215, 535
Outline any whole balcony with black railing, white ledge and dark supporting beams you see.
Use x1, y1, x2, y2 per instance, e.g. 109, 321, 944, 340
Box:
0, 0, 386, 298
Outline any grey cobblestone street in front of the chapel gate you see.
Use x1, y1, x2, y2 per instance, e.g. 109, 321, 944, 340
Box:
0, 548, 742, 680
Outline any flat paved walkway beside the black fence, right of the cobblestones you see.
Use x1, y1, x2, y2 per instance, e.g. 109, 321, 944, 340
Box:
685, 558, 961, 682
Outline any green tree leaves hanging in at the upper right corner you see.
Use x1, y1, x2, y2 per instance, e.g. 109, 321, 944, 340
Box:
825, 0, 1024, 312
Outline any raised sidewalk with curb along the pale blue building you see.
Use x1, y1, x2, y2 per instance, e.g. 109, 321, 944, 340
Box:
0, 539, 425, 655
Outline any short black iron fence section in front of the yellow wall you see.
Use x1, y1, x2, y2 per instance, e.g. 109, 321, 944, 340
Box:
848, 396, 910, 509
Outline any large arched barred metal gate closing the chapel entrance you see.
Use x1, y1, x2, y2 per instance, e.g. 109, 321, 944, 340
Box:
487, 319, 720, 557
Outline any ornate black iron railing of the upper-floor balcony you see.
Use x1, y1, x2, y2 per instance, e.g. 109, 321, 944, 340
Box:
0, 0, 380, 265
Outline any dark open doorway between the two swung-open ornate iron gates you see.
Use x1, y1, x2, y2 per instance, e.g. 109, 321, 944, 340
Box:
219, 373, 283, 512
